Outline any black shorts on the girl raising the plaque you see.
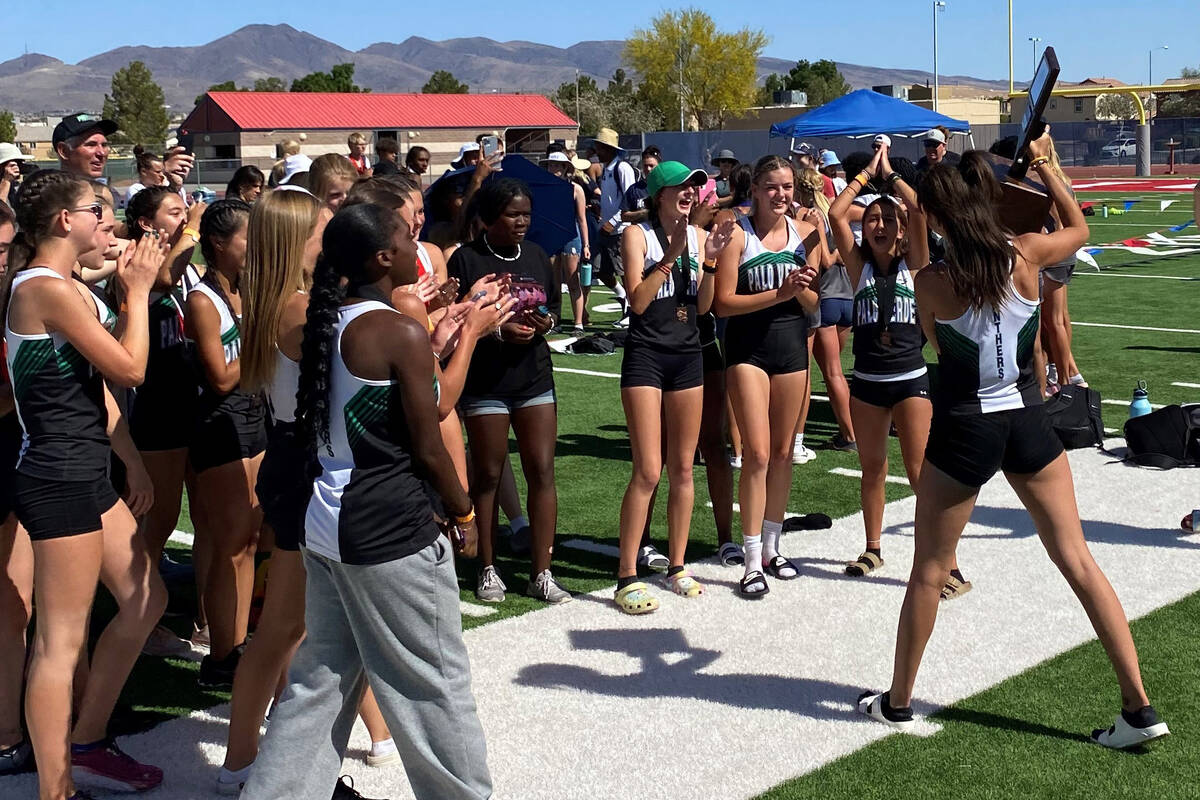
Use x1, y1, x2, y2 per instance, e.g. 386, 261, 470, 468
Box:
925, 403, 1063, 487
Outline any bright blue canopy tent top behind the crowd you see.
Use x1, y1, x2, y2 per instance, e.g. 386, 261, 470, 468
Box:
770, 89, 971, 139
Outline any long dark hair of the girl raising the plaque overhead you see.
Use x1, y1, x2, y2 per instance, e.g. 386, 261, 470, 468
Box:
917, 164, 1014, 309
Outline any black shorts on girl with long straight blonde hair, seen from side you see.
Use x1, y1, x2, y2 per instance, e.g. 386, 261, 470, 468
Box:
254, 422, 312, 551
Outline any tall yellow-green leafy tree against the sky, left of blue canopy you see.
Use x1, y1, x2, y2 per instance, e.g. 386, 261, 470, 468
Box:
625, 8, 767, 128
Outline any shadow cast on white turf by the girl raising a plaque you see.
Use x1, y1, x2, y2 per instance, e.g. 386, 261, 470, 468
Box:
515, 628, 862, 720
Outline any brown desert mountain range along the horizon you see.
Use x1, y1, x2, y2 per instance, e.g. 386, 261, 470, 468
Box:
0, 25, 1007, 114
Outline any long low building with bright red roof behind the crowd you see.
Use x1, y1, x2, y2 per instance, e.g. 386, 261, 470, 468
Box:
181, 91, 578, 183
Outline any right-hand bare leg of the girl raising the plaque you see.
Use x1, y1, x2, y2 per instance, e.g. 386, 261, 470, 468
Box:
1004, 453, 1150, 711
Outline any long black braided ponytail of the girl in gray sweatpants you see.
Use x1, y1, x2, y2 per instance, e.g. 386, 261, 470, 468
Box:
296, 203, 401, 477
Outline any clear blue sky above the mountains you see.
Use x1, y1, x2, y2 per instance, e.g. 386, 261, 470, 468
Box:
0, 0, 1200, 83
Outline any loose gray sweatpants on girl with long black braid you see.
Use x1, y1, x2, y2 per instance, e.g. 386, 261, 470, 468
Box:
241, 537, 492, 800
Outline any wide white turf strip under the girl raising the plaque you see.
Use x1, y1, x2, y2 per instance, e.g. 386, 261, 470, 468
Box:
14, 450, 1200, 800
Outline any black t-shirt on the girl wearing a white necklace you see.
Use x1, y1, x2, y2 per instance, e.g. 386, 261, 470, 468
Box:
446, 236, 562, 399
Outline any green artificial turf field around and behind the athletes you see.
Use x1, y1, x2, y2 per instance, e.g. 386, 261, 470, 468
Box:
108, 192, 1200, 800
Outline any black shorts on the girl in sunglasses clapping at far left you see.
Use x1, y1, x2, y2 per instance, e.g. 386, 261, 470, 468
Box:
13, 470, 120, 541
